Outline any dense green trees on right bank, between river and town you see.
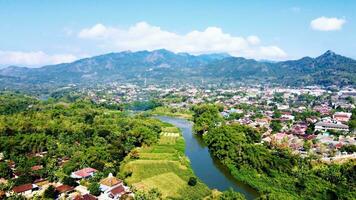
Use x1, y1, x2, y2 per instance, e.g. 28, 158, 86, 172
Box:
193, 104, 356, 199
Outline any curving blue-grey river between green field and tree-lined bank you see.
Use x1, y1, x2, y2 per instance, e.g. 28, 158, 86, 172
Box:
157, 116, 258, 199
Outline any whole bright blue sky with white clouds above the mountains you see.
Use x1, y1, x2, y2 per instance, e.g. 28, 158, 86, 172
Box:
0, 0, 356, 67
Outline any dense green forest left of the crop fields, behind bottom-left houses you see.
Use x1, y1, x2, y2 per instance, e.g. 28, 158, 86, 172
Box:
0, 93, 161, 196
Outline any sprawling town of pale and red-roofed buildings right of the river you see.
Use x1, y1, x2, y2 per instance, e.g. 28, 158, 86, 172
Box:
158, 87, 356, 161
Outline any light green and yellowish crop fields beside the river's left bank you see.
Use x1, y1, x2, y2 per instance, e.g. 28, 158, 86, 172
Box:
120, 124, 211, 199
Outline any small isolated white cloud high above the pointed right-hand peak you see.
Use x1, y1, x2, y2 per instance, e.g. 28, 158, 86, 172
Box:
310, 17, 346, 31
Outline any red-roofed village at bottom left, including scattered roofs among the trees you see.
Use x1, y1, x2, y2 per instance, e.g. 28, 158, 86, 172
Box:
0, 162, 134, 200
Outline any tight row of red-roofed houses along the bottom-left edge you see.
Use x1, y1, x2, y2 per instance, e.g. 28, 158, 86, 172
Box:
0, 168, 133, 200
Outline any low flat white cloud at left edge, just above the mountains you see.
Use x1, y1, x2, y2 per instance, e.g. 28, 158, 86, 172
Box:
0, 50, 77, 67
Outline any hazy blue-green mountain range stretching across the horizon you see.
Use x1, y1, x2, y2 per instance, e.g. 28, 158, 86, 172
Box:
0, 49, 356, 86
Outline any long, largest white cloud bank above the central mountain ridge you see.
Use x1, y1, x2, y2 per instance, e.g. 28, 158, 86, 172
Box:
78, 22, 287, 59
